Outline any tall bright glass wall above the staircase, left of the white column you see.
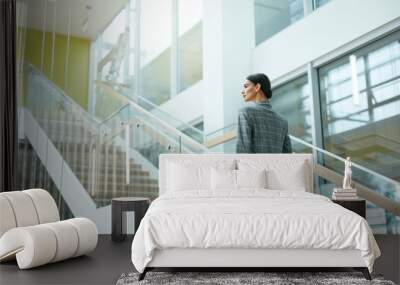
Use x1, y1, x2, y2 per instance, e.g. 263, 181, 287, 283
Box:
92, 0, 203, 107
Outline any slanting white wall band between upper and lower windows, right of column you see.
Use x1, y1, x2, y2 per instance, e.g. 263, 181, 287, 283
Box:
252, 0, 400, 80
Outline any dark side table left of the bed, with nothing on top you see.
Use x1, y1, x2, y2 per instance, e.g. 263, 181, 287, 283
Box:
111, 197, 150, 241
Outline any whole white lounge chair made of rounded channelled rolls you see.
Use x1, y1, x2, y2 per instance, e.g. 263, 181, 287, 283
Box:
0, 189, 98, 269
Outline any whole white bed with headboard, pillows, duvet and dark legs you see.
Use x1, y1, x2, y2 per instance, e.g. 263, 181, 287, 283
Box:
132, 154, 380, 278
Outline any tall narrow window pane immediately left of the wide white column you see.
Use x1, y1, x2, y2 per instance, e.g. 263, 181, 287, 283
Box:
177, 0, 203, 93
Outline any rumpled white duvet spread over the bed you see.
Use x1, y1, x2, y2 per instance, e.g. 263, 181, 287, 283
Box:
132, 189, 380, 272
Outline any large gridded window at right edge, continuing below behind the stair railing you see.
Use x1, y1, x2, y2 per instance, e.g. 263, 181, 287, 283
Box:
319, 33, 400, 233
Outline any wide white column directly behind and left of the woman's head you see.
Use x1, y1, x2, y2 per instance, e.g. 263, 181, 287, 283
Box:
203, 0, 255, 134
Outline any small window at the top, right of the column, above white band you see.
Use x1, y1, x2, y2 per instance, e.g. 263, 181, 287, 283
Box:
254, 0, 304, 45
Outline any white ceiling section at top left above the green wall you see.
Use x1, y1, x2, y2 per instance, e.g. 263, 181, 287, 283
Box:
27, 0, 128, 40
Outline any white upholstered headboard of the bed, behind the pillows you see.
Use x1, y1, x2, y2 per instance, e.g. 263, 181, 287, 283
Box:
158, 153, 313, 195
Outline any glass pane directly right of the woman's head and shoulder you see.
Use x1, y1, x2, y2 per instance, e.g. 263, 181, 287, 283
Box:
271, 75, 312, 152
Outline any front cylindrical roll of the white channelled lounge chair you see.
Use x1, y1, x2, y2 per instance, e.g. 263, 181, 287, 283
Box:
0, 218, 97, 269
